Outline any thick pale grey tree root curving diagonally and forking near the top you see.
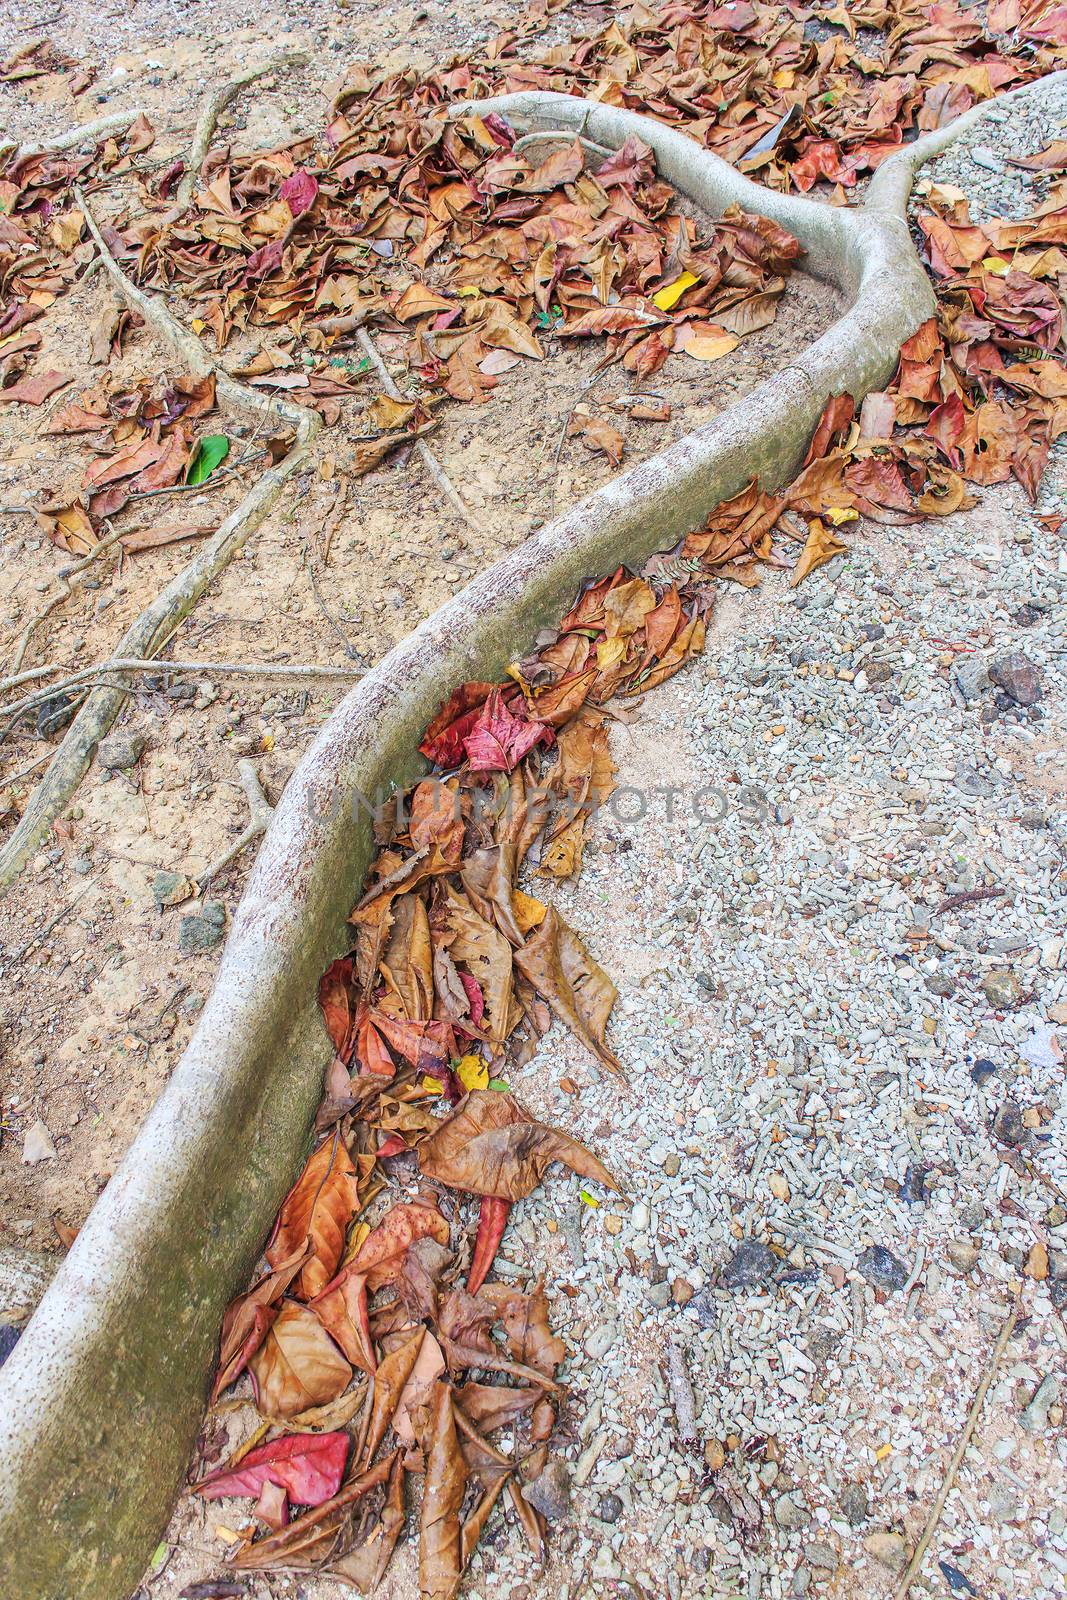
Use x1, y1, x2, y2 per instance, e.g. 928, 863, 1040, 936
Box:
0, 75, 1062, 1600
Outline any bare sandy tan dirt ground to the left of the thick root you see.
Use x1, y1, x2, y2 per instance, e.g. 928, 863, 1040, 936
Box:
0, 5, 835, 1248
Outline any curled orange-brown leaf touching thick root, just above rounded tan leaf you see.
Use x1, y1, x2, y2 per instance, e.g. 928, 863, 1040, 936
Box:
267, 1131, 358, 1299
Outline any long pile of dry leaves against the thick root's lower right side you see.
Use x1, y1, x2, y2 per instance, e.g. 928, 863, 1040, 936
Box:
197, 562, 739, 1580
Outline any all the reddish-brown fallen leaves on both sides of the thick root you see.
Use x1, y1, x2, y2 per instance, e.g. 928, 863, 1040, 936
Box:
0, 0, 1067, 1600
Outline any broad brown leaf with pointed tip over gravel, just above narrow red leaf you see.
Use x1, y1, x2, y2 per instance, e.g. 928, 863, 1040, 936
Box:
418, 1088, 619, 1202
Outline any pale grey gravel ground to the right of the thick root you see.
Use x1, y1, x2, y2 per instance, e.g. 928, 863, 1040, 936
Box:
454, 90, 1067, 1600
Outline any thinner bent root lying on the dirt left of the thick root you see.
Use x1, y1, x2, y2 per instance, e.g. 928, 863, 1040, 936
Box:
0, 189, 322, 894
